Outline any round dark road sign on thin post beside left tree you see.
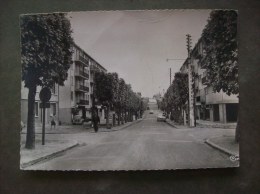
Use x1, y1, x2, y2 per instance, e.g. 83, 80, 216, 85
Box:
40, 87, 51, 145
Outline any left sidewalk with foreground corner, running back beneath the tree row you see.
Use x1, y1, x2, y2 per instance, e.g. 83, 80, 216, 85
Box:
20, 119, 142, 169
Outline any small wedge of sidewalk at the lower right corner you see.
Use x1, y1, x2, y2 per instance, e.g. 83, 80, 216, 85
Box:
205, 136, 239, 159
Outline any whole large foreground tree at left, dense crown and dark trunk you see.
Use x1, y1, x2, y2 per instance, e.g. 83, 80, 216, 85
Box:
20, 13, 73, 149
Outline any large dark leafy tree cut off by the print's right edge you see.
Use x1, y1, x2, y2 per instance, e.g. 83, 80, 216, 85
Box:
202, 10, 239, 141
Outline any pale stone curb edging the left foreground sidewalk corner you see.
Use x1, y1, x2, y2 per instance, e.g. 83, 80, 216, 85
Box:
20, 143, 79, 170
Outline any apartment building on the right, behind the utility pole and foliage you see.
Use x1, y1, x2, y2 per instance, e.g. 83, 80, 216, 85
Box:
180, 39, 238, 123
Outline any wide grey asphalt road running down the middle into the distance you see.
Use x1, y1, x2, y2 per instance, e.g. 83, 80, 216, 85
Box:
27, 102, 237, 170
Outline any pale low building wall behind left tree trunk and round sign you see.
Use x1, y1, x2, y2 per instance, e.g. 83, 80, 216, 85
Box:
21, 82, 59, 126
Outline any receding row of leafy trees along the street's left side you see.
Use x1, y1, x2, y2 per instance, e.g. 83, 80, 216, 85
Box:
93, 71, 144, 125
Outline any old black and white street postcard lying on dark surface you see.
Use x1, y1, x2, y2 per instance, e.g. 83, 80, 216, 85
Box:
19, 9, 242, 171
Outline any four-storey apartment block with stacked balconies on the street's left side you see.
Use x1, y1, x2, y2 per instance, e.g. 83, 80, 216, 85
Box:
59, 44, 107, 124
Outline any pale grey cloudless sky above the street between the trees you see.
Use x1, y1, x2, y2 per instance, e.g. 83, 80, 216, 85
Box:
69, 10, 210, 97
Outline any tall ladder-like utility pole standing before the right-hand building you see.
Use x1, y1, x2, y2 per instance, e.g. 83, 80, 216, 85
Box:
186, 34, 195, 127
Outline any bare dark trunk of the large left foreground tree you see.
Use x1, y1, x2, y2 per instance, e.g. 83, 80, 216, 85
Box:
25, 86, 36, 149
